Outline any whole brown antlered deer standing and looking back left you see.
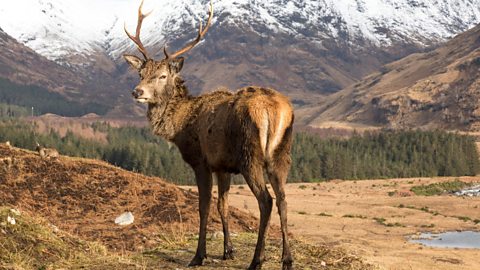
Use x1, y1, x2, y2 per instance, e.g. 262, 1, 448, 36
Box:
123, 0, 294, 269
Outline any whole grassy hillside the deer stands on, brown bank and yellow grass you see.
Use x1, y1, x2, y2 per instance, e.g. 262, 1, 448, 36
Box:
0, 144, 373, 270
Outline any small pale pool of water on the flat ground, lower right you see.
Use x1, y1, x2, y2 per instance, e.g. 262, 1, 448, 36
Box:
409, 231, 480, 248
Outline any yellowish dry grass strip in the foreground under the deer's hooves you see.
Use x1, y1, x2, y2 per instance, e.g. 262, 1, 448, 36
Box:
0, 207, 375, 270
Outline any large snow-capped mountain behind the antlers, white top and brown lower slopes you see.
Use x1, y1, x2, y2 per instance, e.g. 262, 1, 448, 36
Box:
0, 0, 480, 115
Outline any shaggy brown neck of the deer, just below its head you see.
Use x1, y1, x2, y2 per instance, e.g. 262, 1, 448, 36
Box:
147, 97, 191, 142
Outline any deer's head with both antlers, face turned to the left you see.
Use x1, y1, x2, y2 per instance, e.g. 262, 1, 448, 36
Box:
124, 0, 213, 104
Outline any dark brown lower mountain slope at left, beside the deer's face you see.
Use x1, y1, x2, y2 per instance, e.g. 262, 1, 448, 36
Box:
0, 28, 142, 116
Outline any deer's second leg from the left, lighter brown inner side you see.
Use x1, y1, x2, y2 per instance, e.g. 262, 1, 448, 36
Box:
215, 173, 234, 260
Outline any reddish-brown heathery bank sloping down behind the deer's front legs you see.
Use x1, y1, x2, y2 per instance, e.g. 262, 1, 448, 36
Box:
0, 144, 256, 250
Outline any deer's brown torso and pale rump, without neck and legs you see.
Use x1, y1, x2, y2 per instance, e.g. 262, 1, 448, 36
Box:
192, 87, 293, 172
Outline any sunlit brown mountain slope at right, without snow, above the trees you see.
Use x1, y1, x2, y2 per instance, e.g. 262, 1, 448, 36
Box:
300, 25, 480, 131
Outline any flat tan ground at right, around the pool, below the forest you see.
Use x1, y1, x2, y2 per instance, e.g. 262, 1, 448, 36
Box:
213, 177, 480, 270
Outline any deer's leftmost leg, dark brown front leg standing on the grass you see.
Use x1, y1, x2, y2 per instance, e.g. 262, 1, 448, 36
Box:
188, 166, 212, 266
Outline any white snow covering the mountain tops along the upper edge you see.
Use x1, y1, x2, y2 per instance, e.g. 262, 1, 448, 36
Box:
0, 0, 480, 61
